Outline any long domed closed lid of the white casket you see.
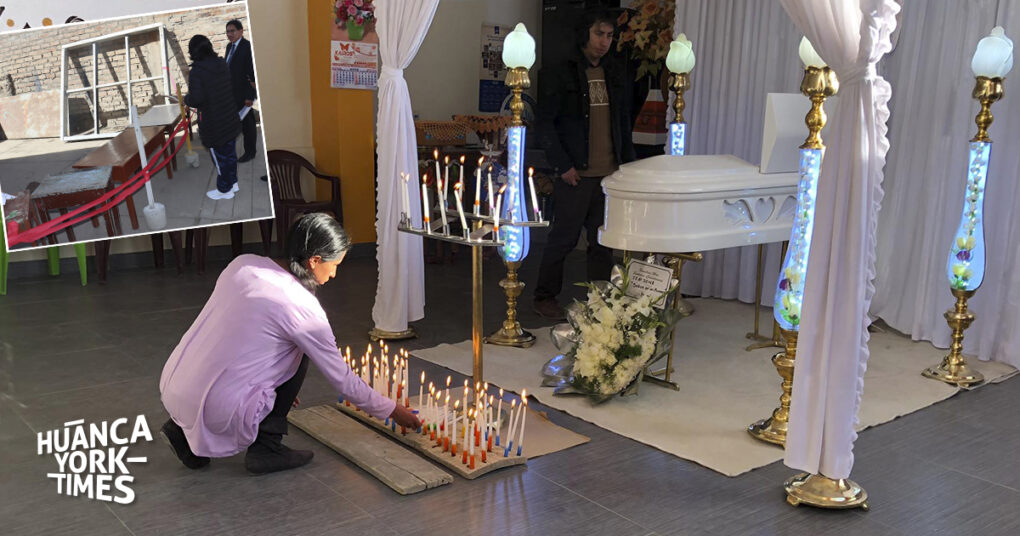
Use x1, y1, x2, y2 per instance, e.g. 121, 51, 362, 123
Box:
602, 154, 796, 194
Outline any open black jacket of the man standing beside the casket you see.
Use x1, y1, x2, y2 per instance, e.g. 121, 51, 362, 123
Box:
536, 49, 635, 175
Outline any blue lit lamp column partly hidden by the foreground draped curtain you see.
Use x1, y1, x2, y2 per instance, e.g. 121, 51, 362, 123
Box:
748, 38, 839, 445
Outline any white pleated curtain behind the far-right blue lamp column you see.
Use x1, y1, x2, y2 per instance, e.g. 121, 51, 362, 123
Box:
871, 0, 1020, 369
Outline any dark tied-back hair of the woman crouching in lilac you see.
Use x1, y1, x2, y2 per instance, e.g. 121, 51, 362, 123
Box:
287, 212, 351, 293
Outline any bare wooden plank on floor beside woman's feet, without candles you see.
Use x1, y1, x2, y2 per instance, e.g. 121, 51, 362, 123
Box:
288, 405, 453, 495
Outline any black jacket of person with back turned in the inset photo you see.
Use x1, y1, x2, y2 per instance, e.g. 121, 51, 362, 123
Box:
185, 56, 241, 147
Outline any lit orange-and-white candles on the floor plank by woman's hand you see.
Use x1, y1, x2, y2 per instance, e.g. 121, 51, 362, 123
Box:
343, 344, 527, 469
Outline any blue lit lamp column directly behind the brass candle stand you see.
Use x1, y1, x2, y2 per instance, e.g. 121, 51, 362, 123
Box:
486, 22, 536, 348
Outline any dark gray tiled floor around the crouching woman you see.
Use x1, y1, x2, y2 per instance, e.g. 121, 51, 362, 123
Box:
0, 242, 1020, 536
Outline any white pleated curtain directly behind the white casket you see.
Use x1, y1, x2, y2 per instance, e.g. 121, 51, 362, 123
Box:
670, 0, 803, 306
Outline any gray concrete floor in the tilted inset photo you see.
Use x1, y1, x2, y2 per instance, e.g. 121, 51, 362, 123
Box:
0, 130, 272, 249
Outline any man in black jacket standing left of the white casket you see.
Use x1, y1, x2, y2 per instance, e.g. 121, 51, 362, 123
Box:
534, 11, 634, 319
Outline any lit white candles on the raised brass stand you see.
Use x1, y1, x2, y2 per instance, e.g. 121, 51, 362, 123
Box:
400, 149, 542, 234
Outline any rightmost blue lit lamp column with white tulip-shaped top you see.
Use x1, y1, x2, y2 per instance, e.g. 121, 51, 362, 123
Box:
921, 27, 1013, 387
